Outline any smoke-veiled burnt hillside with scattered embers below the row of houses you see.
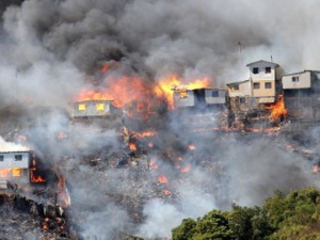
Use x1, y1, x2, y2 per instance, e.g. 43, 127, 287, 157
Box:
2, 109, 319, 239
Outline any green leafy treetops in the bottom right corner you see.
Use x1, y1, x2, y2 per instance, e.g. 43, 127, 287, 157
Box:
172, 188, 320, 240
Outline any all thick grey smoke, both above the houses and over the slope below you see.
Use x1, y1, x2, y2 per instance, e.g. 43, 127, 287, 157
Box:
0, 0, 320, 239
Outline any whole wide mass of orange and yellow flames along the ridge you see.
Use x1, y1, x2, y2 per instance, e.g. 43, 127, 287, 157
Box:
75, 64, 210, 115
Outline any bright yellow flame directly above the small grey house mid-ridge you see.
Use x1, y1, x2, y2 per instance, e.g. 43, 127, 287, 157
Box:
154, 75, 210, 110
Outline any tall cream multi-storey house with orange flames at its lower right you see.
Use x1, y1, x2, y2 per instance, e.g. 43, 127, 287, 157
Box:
227, 60, 281, 127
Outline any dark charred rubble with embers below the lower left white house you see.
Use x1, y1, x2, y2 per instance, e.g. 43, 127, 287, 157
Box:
0, 192, 80, 240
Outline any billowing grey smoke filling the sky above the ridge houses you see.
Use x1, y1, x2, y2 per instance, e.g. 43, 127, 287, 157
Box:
1, 0, 319, 103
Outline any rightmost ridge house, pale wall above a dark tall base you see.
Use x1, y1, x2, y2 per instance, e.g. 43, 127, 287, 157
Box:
282, 70, 320, 124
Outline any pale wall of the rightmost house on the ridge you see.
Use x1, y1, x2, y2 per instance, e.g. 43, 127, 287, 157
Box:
282, 72, 311, 89
